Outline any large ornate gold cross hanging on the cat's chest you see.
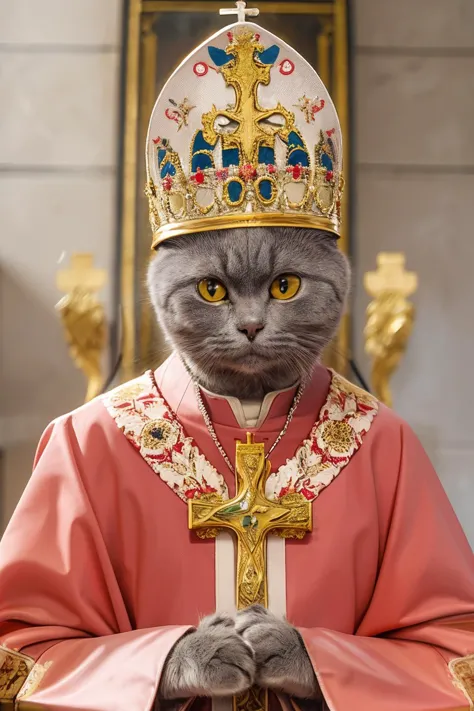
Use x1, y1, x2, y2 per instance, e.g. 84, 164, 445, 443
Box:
188, 434, 312, 711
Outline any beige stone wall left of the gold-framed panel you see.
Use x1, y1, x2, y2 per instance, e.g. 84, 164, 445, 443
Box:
0, 0, 122, 532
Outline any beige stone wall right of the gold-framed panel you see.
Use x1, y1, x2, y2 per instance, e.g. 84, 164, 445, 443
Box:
354, 0, 474, 544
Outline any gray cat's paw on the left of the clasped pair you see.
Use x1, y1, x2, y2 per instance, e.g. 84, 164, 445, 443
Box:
159, 613, 256, 699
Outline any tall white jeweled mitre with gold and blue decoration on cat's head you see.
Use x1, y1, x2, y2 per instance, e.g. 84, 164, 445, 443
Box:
146, 22, 343, 247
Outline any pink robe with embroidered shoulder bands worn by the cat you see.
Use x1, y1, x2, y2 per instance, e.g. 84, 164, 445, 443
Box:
0, 356, 474, 711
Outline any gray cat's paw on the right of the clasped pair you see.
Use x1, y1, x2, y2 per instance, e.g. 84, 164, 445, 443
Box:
235, 605, 321, 699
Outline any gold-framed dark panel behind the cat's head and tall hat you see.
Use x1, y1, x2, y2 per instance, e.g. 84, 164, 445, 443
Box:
119, 0, 350, 380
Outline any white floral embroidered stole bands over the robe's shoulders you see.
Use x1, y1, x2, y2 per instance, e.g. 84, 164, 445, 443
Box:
103, 371, 378, 501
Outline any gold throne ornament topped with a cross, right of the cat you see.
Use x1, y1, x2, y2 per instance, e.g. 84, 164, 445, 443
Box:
364, 252, 418, 407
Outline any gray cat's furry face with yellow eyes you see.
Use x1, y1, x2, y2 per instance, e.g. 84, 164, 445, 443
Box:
148, 227, 349, 398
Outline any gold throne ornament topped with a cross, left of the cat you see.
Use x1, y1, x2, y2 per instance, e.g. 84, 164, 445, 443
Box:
56, 254, 107, 402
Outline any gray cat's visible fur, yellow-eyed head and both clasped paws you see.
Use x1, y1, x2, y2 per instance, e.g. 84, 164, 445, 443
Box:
148, 227, 349, 699
